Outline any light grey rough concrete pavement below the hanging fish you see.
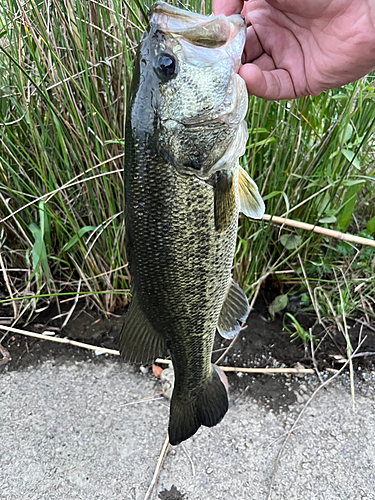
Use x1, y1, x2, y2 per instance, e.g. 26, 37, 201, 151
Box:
0, 356, 375, 500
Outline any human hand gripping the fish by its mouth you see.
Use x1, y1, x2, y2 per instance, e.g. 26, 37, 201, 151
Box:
212, 0, 375, 100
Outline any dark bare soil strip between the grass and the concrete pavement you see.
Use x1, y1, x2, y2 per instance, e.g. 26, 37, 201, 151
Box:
0, 291, 375, 378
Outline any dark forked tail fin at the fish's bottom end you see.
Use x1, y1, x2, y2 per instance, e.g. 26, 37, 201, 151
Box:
169, 368, 228, 445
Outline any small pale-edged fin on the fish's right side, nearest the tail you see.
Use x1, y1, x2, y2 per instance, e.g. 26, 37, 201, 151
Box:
217, 280, 249, 339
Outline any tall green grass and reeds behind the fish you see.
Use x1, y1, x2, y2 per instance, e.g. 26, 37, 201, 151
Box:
0, 0, 375, 336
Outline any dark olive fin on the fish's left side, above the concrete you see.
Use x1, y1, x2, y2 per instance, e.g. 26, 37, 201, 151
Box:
120, 294, 167, 363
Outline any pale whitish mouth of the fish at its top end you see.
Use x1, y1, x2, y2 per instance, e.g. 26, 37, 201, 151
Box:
150, 1, 246, 53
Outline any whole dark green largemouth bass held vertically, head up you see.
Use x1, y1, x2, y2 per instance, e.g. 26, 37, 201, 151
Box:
120, 1, 264, 445
